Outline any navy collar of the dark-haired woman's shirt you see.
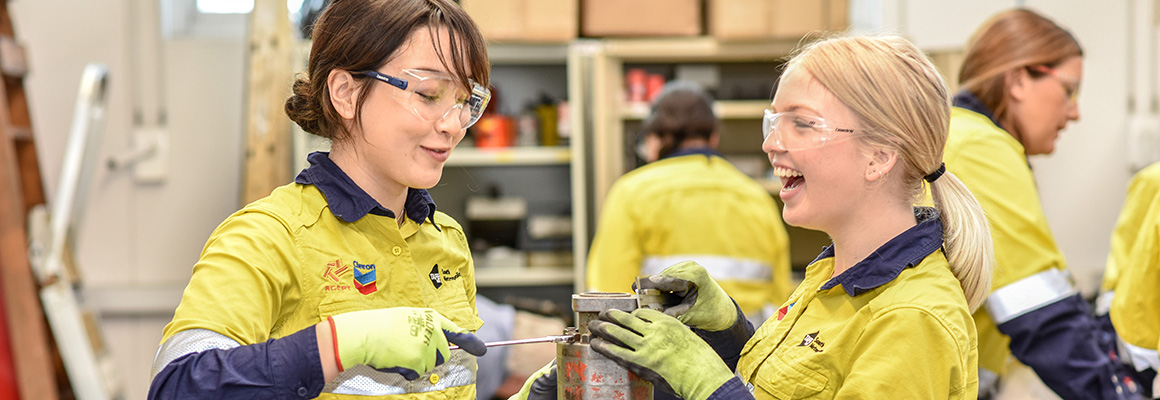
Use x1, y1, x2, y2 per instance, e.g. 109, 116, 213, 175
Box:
293, 152, 435, 225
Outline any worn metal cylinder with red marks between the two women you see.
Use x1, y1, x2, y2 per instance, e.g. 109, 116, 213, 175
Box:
556, 292, 653, 400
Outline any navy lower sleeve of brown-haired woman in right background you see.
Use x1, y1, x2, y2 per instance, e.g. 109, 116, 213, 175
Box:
999, 294, 1132, 400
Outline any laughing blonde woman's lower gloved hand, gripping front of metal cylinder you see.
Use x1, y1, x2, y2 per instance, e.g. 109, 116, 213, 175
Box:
588, 308, 733, 400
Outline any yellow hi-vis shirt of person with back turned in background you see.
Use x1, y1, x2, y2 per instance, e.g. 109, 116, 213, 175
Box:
587, 153, 791, 317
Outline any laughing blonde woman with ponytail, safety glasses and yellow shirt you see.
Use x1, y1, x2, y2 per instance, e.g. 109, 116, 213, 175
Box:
531, 37, 993, 400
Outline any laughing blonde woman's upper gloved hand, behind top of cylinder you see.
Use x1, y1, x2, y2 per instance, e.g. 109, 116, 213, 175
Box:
632, 261, 738, 332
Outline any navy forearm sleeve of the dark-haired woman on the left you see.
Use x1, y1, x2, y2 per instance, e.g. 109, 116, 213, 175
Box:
148, 326, 326, 400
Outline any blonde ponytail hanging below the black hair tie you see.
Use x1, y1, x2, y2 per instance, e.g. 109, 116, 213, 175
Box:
930, 172, 995, 313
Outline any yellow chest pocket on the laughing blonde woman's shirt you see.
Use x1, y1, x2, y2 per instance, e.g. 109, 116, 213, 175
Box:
753, 352, 829, 400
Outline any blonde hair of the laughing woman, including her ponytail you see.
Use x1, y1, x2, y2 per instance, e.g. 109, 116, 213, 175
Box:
786, 36, 994, 312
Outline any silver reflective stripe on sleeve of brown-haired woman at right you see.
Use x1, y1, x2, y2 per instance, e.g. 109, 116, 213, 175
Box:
986, 269, 1076, 325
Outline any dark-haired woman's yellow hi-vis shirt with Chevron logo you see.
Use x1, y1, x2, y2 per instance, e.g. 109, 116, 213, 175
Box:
161, 183, 483, 400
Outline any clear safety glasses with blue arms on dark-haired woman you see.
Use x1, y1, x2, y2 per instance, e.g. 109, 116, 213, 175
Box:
362, 70, 492, 129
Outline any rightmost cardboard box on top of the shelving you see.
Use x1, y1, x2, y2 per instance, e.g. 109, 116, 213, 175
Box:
705, 0, 849, 41
